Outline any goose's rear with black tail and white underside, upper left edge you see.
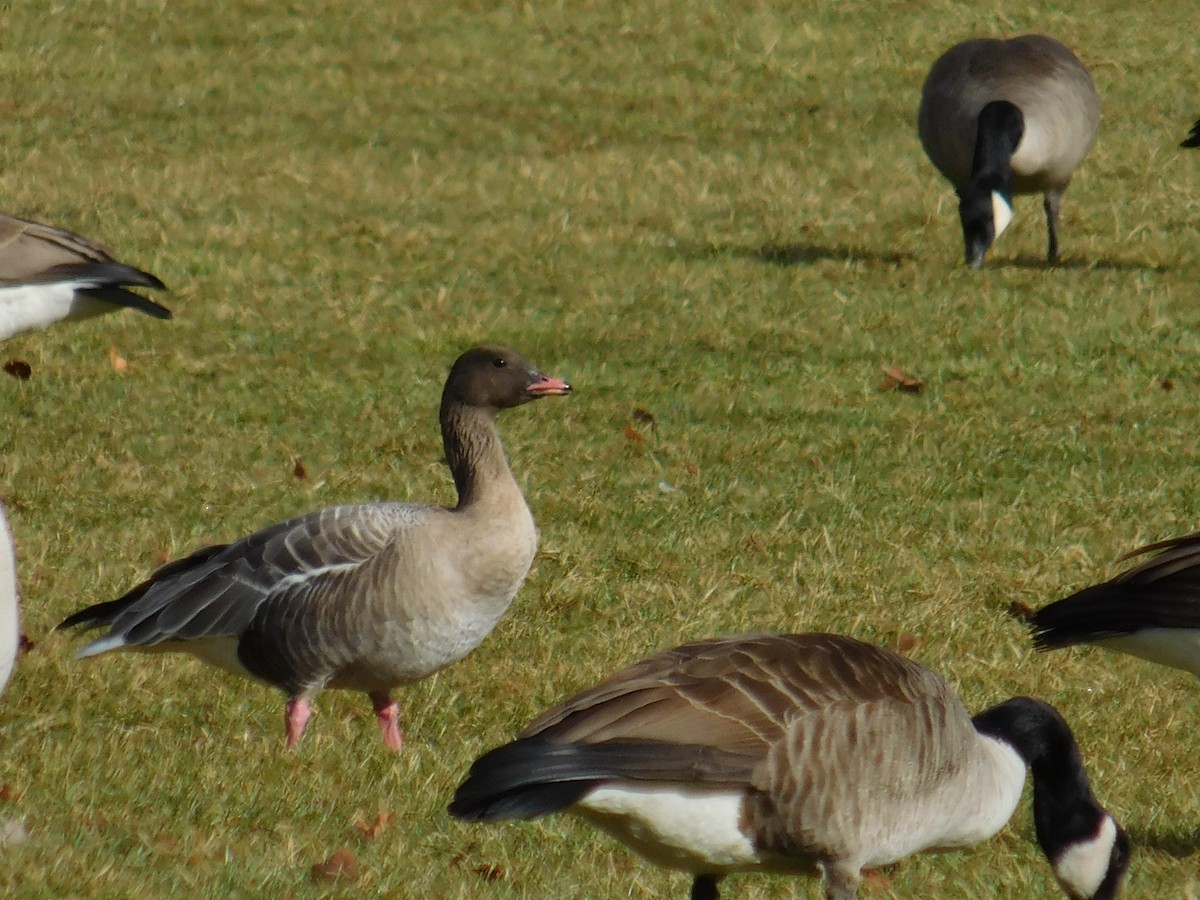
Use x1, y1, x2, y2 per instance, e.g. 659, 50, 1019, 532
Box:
0, 212, 170, 341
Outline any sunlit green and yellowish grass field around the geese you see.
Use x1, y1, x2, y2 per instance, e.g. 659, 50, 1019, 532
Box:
0, 0, 1200, 898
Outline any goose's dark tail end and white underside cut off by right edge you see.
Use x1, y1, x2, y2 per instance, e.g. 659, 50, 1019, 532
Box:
1028, 533, 1200, 676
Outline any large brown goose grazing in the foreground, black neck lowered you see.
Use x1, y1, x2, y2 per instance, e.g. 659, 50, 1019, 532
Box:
450, 634, 1129, 900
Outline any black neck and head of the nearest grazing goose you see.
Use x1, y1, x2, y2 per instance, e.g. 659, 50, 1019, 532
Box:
973, 697, 1129, 898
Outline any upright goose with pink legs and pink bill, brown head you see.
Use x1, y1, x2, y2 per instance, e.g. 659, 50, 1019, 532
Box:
59, 347, 571, 750
